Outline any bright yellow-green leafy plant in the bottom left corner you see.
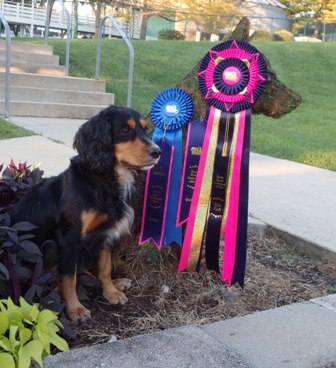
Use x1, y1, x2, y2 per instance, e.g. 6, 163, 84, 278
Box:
0, 298, 69, 368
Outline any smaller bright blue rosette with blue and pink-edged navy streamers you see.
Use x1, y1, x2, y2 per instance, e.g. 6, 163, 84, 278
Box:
139, 88, 194, 248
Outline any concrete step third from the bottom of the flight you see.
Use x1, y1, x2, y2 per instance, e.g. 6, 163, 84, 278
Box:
0, 73, 105, 95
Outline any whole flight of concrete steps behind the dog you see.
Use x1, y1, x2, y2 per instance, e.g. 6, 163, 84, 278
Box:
0, 40, 114, 119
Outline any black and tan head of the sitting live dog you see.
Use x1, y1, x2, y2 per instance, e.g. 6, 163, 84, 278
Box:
73, 106, 161, 170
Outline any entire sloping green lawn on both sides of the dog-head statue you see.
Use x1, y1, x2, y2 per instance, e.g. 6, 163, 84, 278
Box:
10, 39, 336, 171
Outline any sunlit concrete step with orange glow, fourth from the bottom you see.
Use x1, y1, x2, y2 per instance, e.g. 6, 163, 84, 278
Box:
0, 62, 65, 75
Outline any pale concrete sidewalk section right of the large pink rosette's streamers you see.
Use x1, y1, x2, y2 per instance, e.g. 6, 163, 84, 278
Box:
249, 153, 336, 260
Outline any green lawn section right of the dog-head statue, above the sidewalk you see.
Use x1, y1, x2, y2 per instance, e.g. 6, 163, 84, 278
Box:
252, 42, 336, 171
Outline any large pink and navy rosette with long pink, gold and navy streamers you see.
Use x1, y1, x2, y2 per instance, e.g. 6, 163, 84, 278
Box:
177, 40, 267, 287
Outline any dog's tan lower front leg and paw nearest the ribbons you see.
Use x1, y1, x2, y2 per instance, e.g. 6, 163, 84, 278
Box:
98, 248, 128, 304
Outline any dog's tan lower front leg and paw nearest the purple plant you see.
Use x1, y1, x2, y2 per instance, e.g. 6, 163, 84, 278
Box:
60, 274, 90, 321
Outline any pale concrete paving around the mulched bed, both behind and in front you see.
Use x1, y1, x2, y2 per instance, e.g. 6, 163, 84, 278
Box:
0, 118, 336, 368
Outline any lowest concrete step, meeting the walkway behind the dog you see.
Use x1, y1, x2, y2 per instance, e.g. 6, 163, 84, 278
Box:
0, 100, 106, 119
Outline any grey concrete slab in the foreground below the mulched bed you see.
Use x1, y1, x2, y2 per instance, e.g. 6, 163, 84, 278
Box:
44, 295, 336, 368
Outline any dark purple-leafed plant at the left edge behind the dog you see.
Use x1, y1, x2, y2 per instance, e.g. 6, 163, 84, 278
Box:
0, 160, 62, 312
